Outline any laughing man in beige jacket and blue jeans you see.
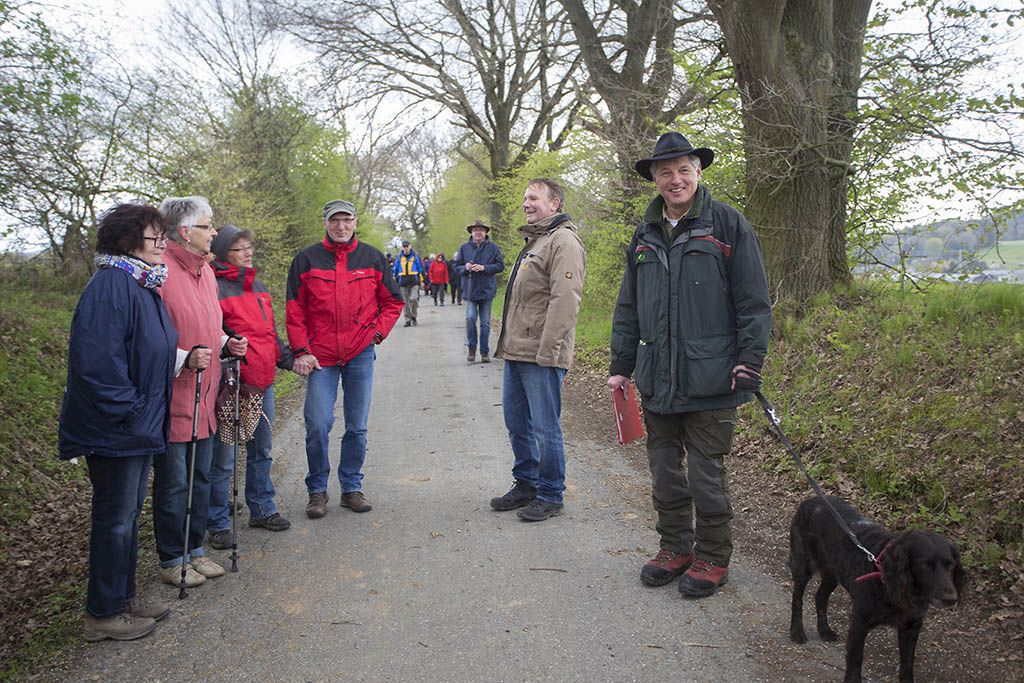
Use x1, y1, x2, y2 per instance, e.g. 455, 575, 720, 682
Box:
490, 178, 587, 521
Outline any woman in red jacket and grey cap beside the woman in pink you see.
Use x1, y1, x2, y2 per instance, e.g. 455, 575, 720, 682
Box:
207, 225, 293, 550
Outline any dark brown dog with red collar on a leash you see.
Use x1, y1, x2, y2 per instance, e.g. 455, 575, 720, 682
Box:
790, 496, 966, 683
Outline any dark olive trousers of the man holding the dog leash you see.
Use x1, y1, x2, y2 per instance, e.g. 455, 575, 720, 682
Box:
644, 408, 736, 566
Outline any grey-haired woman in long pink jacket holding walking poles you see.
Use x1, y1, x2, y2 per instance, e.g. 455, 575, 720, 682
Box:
153, 197, 247, 586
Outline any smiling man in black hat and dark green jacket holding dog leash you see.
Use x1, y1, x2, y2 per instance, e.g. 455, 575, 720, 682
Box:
608, 133, 771, 598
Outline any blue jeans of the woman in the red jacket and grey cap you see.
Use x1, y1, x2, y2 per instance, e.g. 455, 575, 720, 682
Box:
207, 385, 278, 531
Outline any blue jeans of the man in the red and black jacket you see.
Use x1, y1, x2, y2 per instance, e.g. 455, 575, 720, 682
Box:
304, 345, 377, 494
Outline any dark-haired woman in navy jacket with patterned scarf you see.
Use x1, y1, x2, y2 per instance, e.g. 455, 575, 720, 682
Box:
59, 204, 178, 641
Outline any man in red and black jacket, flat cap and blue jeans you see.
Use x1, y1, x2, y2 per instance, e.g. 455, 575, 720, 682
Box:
285, 200, 403, 519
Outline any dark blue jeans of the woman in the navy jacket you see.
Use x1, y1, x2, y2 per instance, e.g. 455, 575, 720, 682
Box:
85, 456, 153, 617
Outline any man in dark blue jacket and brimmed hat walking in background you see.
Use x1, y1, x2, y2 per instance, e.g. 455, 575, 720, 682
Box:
454, 220, 505, 362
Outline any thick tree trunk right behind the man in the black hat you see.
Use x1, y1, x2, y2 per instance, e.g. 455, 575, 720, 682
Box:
709, 0, 870, 301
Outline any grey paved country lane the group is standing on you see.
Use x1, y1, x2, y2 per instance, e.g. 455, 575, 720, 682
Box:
51, 301, 842, 682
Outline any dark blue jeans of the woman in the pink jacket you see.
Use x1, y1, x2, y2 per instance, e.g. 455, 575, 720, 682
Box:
153, 436, 213, 568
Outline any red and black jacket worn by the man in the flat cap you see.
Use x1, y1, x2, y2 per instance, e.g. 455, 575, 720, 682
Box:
285, 237, 404, 366
